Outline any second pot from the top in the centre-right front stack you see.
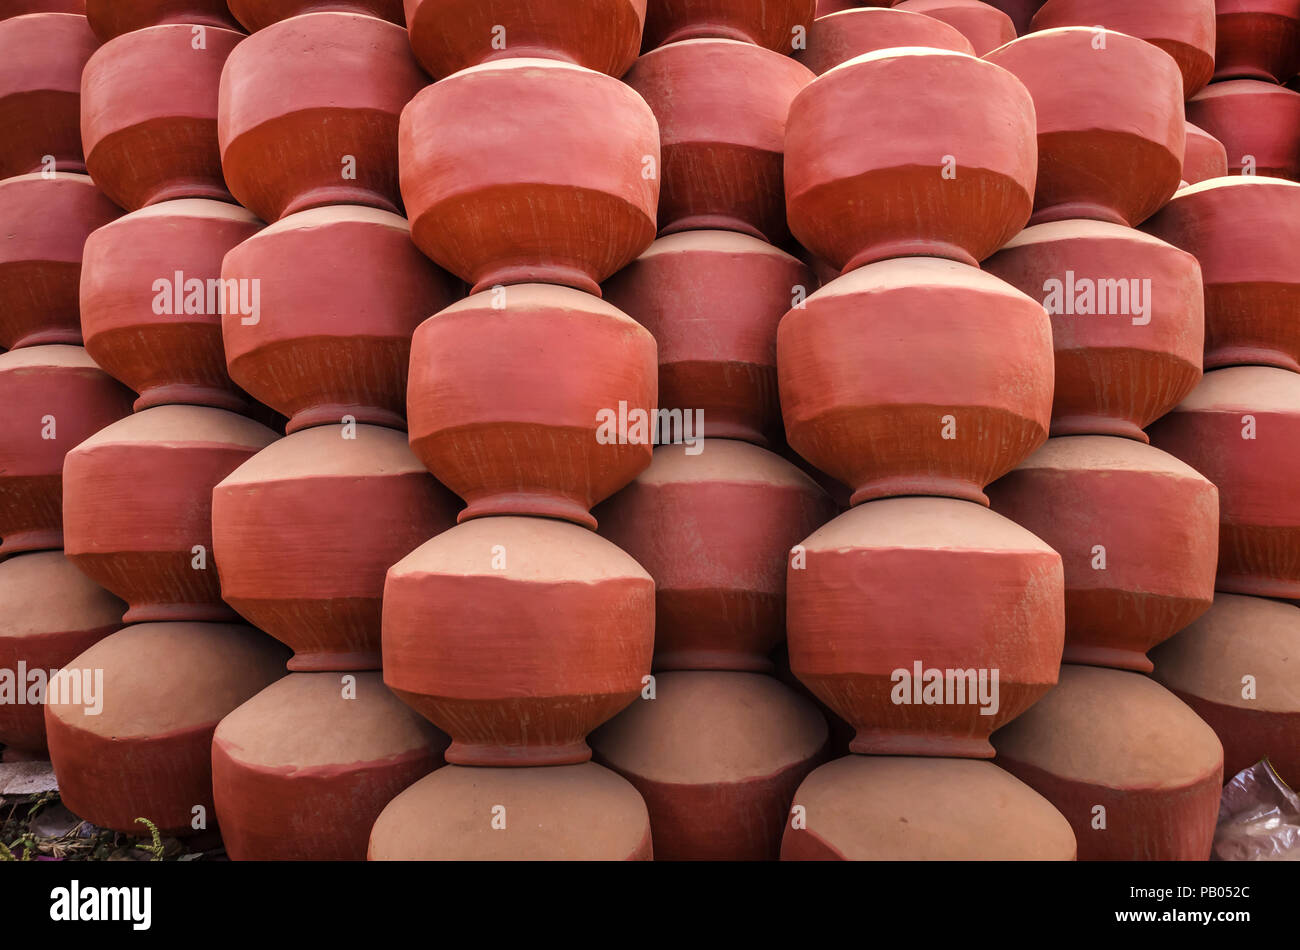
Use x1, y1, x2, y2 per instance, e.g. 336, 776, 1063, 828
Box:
776, 257, 1053, 504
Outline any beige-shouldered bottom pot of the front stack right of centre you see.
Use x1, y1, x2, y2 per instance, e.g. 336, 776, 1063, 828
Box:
781, 755, 1075, 860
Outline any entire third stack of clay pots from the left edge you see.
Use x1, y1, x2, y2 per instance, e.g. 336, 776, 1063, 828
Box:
212, 9, 478, 860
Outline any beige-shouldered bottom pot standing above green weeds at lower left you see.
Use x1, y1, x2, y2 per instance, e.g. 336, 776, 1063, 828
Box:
46, 623, 289, 838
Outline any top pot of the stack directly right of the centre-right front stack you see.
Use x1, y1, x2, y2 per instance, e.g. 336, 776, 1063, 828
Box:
985, 27, 1186, 227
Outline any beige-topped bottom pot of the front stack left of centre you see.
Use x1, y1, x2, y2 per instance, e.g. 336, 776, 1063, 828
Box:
367, 762, 653, 860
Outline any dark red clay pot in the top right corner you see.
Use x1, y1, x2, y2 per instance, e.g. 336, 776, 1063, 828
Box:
1214, 0, 1300, 82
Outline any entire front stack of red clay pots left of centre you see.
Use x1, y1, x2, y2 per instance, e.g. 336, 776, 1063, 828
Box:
368, 9, 660, 860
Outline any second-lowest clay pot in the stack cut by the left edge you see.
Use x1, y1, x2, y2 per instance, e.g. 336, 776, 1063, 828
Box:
0, 346, 131, 558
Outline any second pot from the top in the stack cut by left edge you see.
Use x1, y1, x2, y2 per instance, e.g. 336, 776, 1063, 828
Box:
0, 173, 122, 350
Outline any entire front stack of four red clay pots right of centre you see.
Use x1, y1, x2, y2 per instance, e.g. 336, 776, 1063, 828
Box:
777, 42, 1075, 860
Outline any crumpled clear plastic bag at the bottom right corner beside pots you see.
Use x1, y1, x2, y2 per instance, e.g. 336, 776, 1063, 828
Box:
1212, 759, 1300, 860
